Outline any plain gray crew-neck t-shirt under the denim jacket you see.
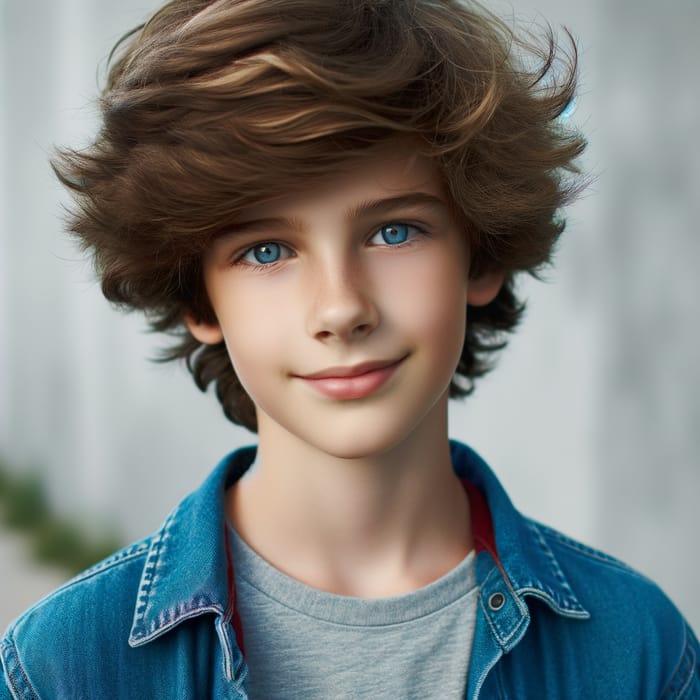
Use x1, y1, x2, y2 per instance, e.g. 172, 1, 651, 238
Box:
229, 528, 478, 700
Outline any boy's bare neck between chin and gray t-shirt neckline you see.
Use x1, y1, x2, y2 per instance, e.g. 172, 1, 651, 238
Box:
228, 407, 472, 598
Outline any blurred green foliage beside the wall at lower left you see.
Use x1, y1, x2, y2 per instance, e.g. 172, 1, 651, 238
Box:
0, 460, 121, 574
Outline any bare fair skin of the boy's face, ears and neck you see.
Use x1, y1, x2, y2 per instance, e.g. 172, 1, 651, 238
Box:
188, 143, 502, 597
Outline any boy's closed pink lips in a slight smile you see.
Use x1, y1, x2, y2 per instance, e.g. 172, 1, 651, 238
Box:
299, 357, 406, 401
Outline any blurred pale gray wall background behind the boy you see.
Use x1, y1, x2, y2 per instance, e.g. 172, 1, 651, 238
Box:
0, 0, 700, 629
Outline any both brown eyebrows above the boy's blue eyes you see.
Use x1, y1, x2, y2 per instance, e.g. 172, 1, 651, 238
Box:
223, 192, 448, 238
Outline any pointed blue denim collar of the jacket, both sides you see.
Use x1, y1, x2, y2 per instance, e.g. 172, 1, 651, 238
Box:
129, 442, 589, 649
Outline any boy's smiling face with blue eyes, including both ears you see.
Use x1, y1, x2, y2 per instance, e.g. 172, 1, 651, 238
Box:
188, 143, 502, 458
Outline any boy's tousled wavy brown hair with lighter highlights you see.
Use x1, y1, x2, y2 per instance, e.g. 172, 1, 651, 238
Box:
54, 0, 584, 430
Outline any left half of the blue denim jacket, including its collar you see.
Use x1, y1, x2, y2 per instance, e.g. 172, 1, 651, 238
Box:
0, 448, 246, 700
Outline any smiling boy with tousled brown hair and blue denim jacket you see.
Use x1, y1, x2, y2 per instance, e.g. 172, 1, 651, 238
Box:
0, 0, 700, 698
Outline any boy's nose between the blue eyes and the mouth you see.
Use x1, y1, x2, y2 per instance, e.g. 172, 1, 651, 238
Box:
308, 258, 379, 342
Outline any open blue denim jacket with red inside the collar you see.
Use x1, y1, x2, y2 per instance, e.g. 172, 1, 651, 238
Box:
0, 443, 700, 700
